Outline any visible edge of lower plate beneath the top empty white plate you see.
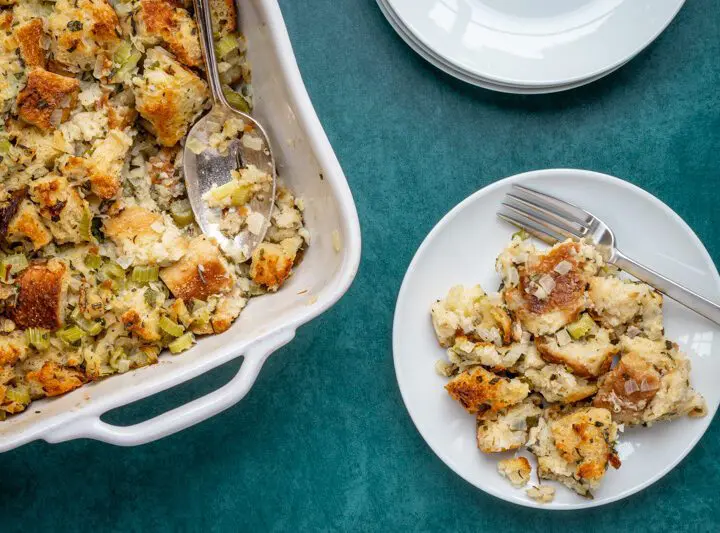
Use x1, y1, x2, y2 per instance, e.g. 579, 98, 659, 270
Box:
377, 0, 625, 94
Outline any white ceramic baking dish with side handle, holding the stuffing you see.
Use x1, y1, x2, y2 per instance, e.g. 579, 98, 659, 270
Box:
0, 0, 360, 452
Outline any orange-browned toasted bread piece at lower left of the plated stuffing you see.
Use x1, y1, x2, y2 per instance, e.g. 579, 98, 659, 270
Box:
445, 367, 530, 415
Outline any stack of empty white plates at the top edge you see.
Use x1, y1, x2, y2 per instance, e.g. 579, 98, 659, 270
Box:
377, 0, 685, 94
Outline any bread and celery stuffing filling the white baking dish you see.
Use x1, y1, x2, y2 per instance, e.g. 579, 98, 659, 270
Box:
0, 0, 309, 419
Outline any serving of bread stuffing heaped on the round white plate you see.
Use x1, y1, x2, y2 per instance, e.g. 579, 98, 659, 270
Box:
431, 232, 707, 503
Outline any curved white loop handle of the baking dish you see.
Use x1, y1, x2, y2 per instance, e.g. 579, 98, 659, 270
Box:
42, 329, 295, 446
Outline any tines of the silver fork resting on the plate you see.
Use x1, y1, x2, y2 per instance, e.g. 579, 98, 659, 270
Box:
498, 184, 595, 244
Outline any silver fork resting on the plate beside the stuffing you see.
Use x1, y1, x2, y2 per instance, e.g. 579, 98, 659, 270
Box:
498, 184, 720, 325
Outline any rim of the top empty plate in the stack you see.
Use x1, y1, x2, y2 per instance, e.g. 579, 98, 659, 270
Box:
385, 0, 686, 88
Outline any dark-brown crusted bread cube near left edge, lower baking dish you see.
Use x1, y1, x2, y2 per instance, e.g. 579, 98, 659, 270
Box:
8, 259, 68, 330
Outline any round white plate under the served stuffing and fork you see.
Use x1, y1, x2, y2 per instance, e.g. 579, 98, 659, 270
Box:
393, 169, 720, 509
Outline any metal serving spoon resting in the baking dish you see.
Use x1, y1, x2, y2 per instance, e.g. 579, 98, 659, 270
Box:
183, 0, 277, 258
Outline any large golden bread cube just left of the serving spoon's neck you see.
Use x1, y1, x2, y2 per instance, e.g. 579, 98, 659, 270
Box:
134, 47, 208, 146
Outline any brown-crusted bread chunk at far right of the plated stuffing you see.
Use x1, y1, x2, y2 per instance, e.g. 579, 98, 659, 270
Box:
593, 337, 707, 424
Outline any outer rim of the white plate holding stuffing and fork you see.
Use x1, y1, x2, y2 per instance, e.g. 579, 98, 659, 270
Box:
392, 168, 720, 511
